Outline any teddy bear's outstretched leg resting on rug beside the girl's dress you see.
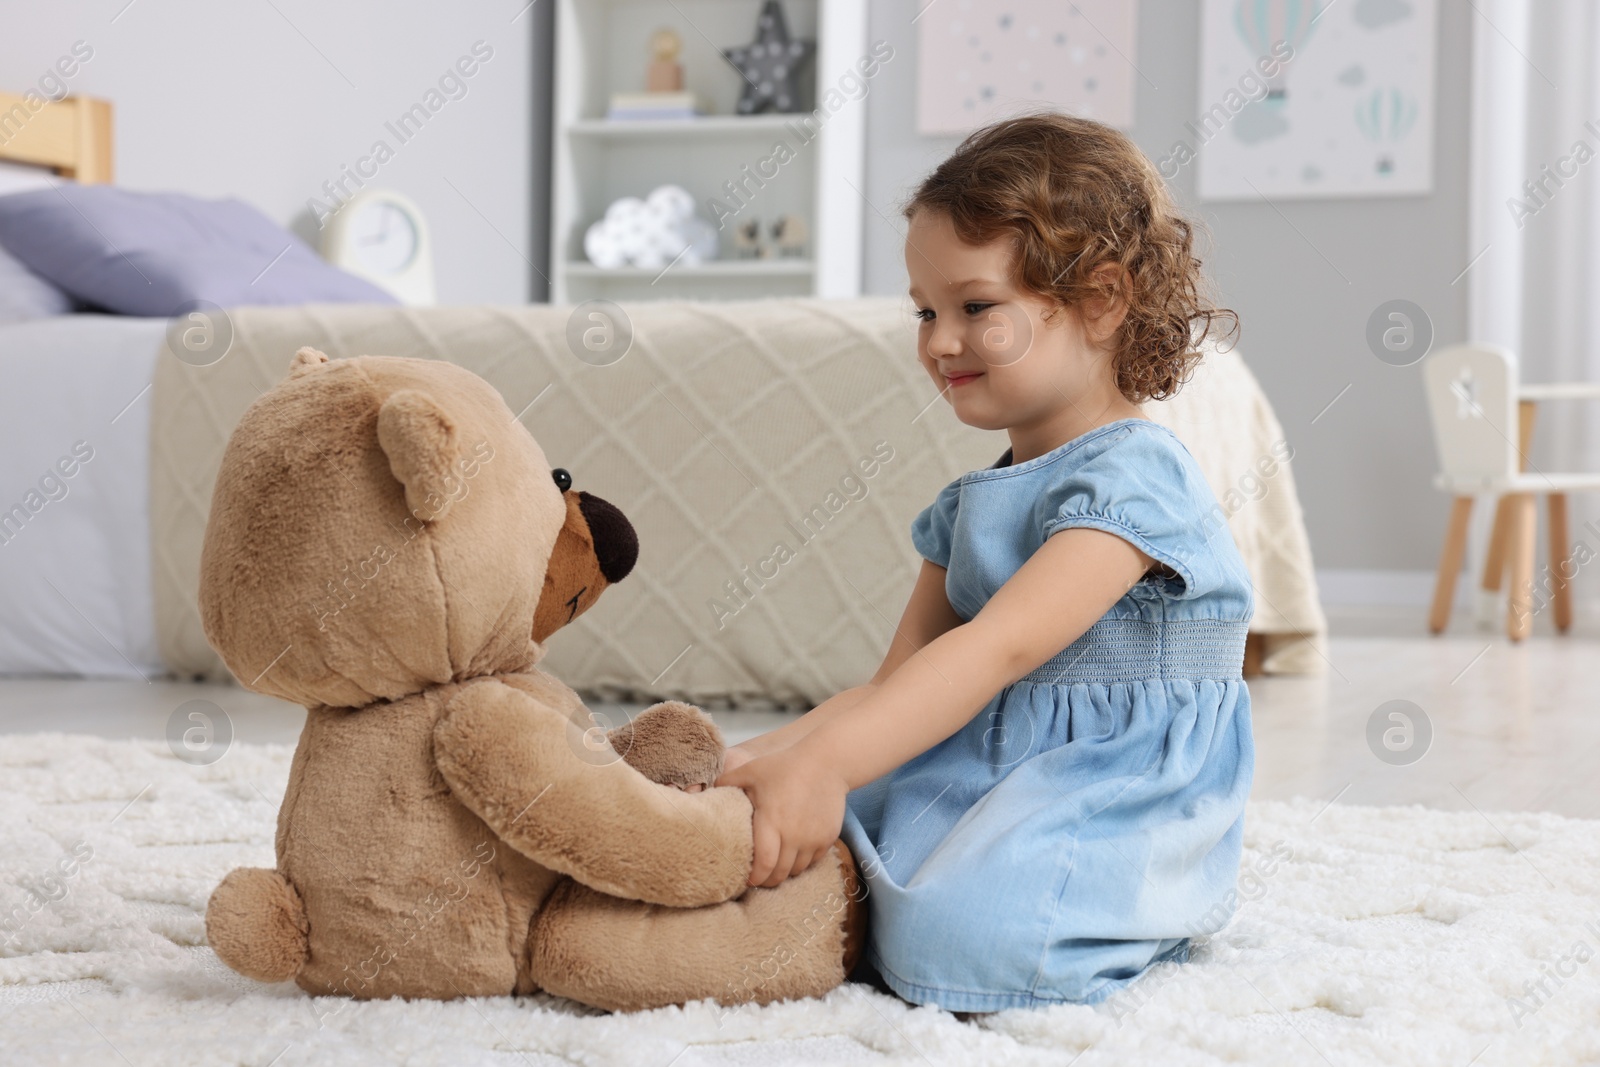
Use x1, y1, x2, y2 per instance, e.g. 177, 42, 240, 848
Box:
530, 841, 866, 1011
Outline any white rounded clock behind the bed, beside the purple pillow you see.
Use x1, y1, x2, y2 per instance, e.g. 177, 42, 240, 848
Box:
322, 189, 434, 306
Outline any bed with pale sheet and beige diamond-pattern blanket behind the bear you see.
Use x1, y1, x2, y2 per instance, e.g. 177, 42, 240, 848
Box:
0, 93, 1326, 705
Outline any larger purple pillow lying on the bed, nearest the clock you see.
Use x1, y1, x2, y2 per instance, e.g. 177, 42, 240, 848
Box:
0, 184, 395, 318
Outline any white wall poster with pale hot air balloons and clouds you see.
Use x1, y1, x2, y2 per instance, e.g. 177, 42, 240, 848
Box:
1190, 0, 1437, 200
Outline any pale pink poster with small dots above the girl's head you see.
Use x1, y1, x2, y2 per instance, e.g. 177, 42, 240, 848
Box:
917, 0, 1139, 134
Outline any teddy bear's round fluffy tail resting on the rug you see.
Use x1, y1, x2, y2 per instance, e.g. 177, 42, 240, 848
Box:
205, 867, 310, 982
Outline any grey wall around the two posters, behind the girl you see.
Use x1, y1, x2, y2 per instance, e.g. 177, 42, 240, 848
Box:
866, 0, 1472, 569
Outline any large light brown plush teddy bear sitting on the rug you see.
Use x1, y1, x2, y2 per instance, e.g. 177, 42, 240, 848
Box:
209, 349, 864, 1011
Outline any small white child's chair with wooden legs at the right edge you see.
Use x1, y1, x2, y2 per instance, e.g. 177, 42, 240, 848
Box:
1422, 344, 1600, 641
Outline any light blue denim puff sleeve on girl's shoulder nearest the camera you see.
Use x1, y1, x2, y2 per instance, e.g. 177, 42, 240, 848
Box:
1038, 424, 1248, 600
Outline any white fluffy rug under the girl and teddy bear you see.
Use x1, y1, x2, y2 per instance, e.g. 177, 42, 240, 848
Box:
0, 734, 1600, 1067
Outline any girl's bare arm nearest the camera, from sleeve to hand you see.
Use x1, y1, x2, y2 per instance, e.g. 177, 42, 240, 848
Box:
718, 528, 1152, 886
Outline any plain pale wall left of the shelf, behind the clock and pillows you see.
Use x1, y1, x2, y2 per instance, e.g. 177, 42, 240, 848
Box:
0, 0, 537, 302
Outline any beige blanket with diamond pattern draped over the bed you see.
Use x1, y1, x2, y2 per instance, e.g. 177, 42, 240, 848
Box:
150, 299, 1325, 704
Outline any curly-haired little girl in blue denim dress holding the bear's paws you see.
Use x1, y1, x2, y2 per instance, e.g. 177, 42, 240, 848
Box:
717, 115, 1254, 1013
